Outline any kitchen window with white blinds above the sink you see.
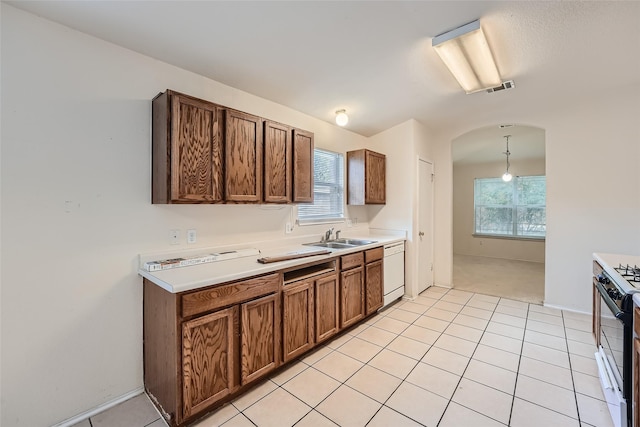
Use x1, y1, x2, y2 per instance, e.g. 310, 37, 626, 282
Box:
298, 149, 344, 224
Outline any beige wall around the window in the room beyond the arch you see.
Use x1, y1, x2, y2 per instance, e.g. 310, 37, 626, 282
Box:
453, 159, 545, 264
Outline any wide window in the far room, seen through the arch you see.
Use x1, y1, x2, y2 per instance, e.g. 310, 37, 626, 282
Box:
474, 176, 547, 238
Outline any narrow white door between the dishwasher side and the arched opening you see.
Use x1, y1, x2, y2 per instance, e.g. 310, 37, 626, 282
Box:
416, 159, 434, 293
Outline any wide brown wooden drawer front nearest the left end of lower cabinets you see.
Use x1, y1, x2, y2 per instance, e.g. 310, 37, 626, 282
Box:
182, 273, 280, 317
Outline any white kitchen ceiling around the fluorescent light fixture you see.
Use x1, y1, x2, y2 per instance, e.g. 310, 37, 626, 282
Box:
6, 0, 640, 136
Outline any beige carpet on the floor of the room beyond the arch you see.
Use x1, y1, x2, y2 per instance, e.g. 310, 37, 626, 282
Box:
453, 254, 544, 304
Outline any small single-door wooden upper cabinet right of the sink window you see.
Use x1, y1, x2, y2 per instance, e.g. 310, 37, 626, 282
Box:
347, 149, 387, 205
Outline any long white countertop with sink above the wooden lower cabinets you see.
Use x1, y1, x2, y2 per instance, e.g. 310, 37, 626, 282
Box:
138, 233, 406, 293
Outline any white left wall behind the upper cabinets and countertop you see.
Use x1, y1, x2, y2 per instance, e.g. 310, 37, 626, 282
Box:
0, 3, 378, 427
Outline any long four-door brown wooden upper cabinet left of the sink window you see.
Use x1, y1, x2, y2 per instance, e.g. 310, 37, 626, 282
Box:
152, 90, 314, 203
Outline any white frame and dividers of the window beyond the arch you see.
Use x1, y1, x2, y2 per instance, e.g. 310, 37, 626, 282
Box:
472, 175, 547, 241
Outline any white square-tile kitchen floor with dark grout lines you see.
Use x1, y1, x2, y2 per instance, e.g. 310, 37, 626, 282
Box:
80, 287, 612, 427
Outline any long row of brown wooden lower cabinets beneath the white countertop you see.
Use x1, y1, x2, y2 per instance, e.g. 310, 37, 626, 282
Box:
143, 248, 390, 427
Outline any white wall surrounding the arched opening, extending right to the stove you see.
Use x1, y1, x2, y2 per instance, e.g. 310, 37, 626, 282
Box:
434, 86, 640, 312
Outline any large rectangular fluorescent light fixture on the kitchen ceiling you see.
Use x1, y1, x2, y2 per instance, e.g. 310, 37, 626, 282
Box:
431, 20, 502, 93
